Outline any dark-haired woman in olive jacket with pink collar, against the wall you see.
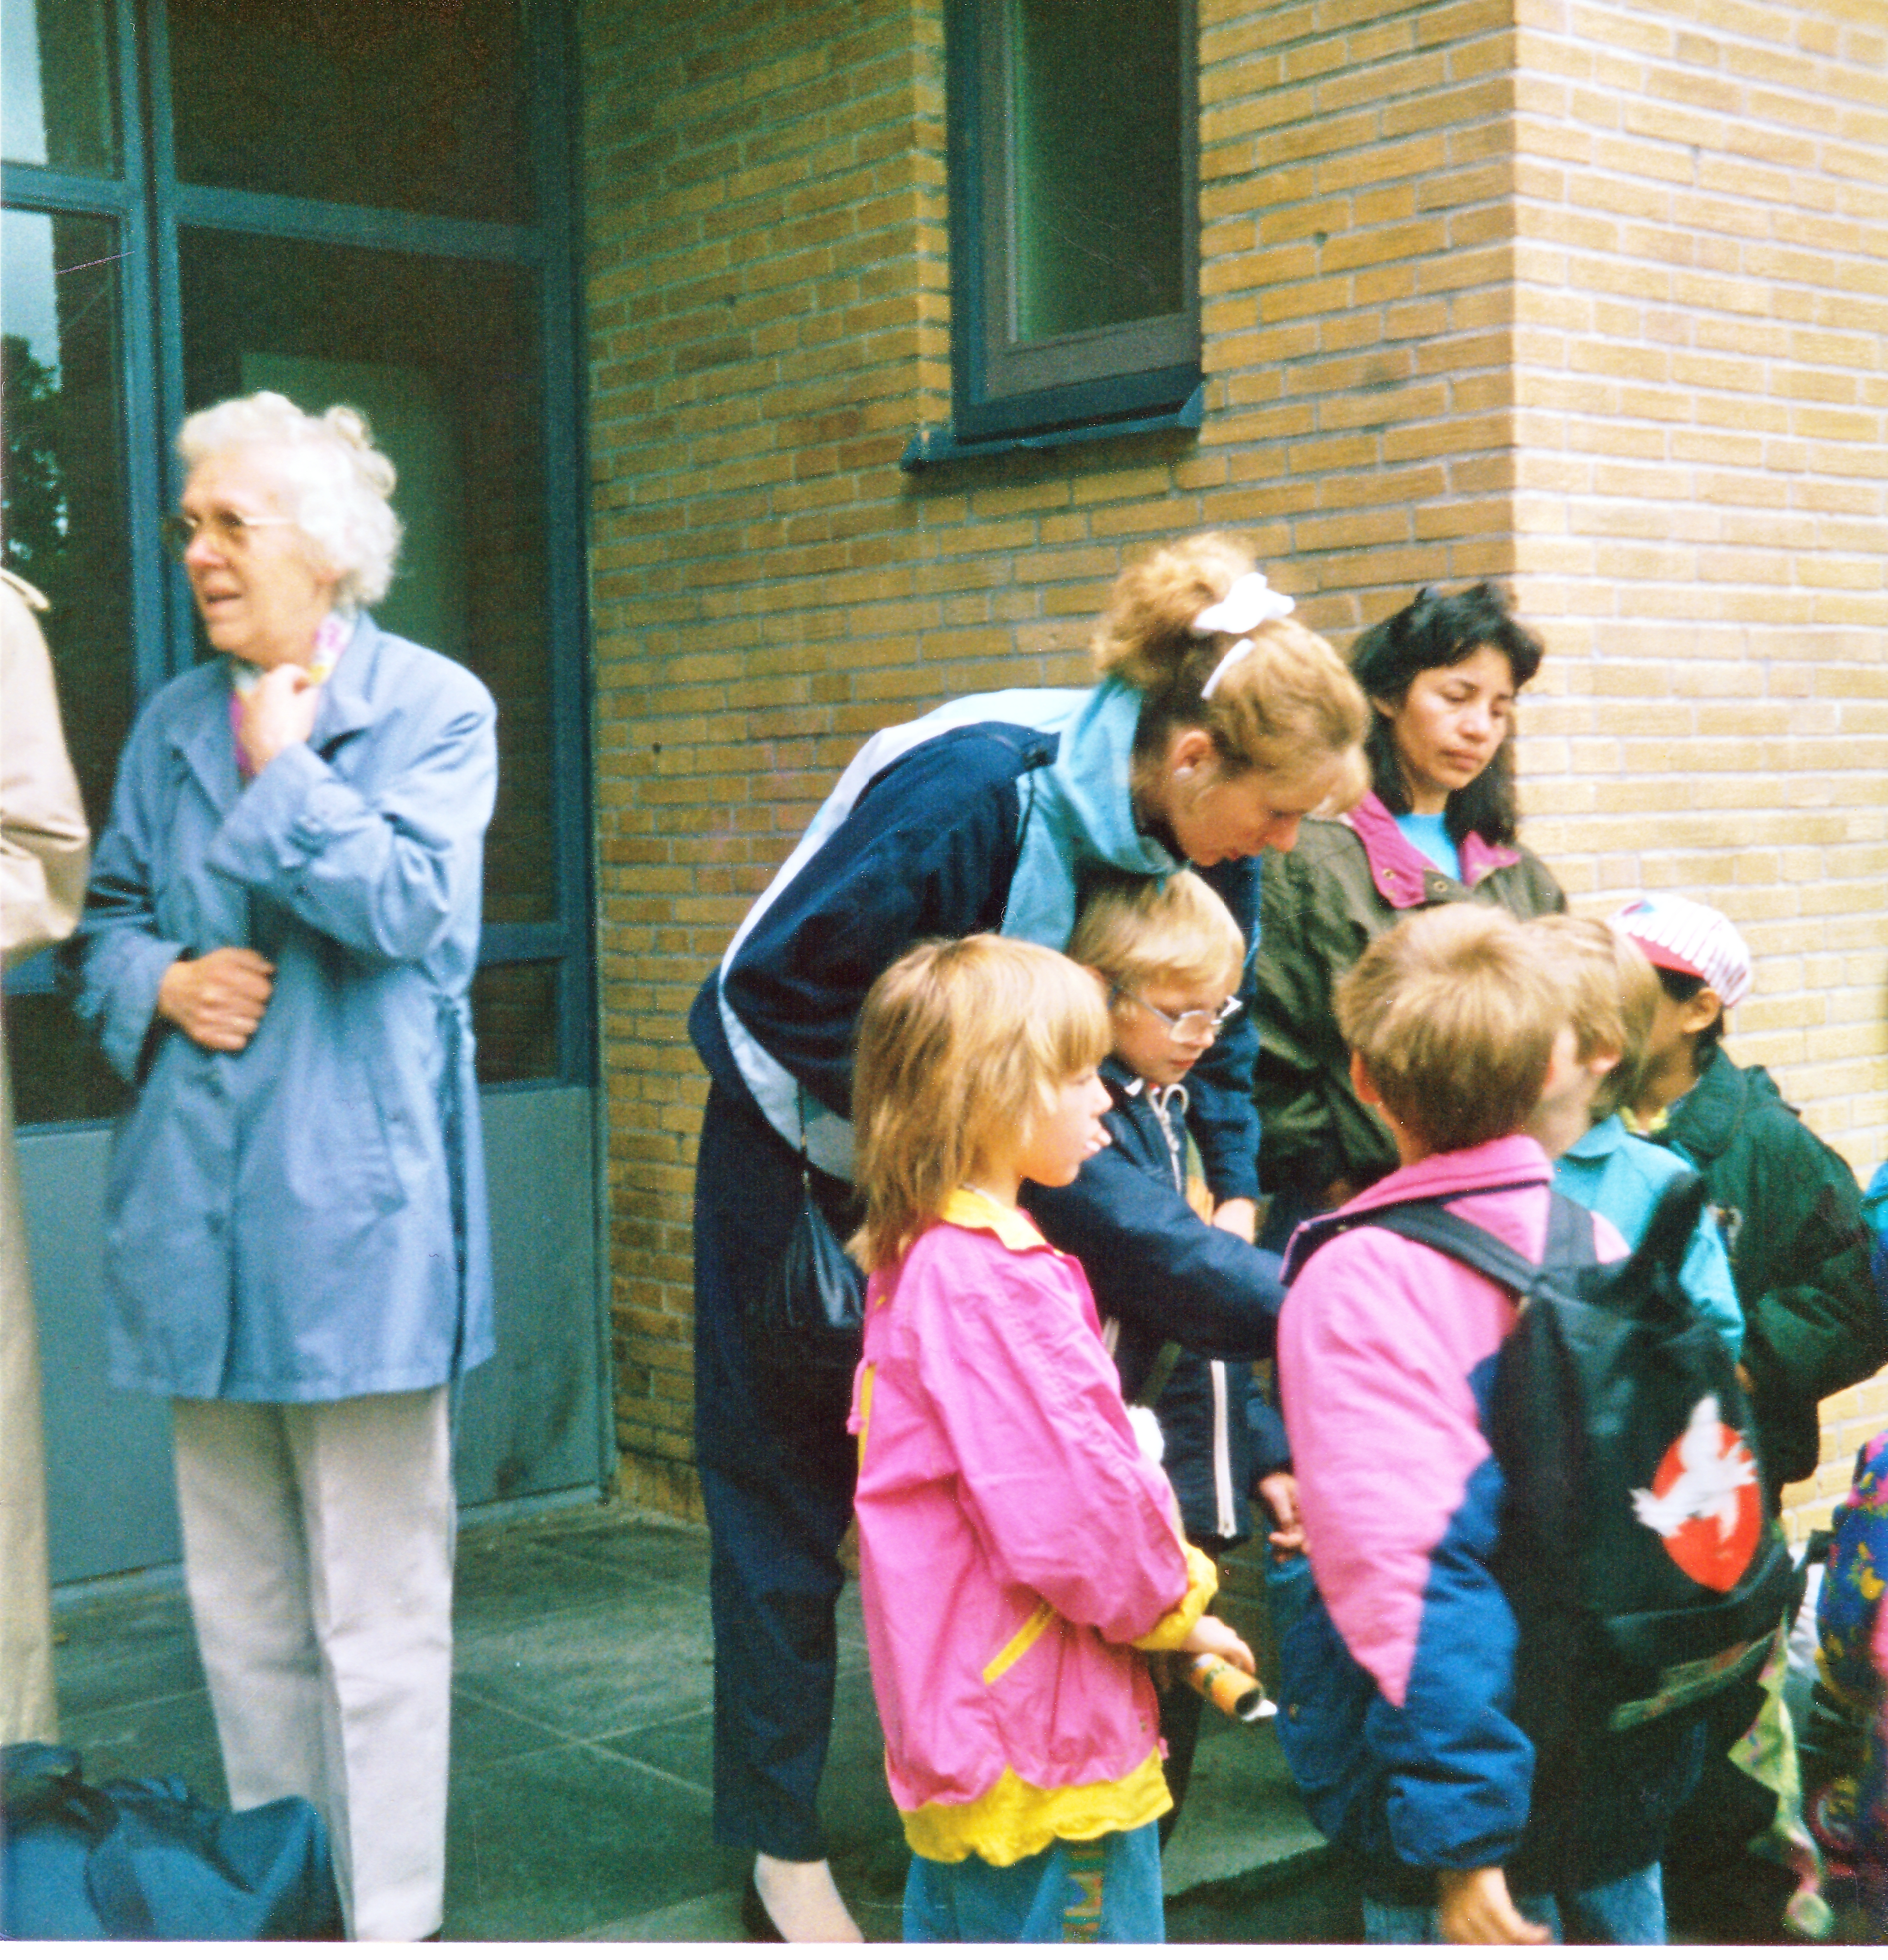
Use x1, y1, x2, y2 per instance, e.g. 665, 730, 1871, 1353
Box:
1253, 582, 1566, 1246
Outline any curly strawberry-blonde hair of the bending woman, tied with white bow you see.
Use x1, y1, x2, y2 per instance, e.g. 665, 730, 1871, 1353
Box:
1094, 531, 1370, 792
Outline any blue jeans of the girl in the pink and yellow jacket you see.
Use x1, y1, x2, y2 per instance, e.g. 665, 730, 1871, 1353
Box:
904, 1825, 1166, 1946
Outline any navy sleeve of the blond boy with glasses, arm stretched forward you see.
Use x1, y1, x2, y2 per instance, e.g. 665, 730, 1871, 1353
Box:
1023, 1119, 1284, 1360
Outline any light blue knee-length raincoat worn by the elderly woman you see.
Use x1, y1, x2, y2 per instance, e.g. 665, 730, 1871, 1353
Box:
65, 615, 498, 1401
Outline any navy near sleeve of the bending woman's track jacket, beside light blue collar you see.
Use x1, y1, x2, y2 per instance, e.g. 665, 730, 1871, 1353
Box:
724, 725, 1053, 1115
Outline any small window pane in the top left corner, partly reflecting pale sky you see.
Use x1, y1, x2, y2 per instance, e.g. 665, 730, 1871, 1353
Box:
0, 0, 118, 173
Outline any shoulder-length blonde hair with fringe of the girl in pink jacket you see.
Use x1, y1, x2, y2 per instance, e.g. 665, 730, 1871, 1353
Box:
851, 933, 1112, 1270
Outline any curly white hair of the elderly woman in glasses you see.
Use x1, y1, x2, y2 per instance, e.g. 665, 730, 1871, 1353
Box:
176, 388, 400, 596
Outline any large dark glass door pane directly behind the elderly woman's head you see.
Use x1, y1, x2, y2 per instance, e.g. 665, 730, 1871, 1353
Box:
180, 231, 557, 923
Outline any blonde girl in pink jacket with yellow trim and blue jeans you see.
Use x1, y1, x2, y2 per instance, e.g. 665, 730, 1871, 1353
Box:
851, 935, 1253, 1942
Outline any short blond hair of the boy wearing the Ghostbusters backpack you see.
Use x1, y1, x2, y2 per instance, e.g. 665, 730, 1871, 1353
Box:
1335, 906, 1571, 1151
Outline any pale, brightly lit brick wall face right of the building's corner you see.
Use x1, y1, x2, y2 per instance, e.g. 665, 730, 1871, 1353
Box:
1513, 0, 1888, 1533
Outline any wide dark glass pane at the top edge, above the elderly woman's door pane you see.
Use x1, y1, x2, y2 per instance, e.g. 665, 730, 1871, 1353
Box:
169, 0, 529, 224
